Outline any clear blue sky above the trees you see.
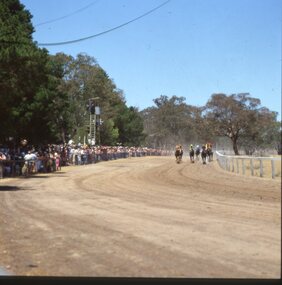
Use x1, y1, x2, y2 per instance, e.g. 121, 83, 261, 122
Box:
21, 0, 282, 120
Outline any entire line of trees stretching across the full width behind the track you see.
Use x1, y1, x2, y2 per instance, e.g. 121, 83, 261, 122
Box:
0, 0, 281, 154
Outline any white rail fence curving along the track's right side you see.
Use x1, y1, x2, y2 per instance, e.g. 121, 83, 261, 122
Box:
216, 151, 281, 179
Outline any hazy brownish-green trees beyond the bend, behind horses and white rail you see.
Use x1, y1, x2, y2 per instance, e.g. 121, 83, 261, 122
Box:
141, 93, 281, 155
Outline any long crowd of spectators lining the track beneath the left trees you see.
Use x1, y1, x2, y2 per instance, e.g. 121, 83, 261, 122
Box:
0, 142, 170, 178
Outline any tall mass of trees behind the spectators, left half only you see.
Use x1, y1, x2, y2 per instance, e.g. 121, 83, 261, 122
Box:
0, 0, 144, 149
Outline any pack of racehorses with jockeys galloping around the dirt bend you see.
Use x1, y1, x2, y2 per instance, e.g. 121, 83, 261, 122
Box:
175, 143, 213, 164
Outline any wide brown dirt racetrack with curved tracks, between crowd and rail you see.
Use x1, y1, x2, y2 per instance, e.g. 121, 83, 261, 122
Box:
0, 157, 281, 278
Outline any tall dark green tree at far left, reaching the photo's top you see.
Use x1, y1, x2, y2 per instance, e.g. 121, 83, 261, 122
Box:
0, 0, 68, 144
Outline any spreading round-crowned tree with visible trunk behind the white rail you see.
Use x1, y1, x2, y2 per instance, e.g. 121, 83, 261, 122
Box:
204, 93, 276, 155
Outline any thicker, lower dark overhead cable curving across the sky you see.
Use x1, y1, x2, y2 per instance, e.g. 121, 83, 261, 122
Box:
38, 0, 170, 46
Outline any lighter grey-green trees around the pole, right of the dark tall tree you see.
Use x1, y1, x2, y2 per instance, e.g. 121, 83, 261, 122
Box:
50, 53, 144, 145
